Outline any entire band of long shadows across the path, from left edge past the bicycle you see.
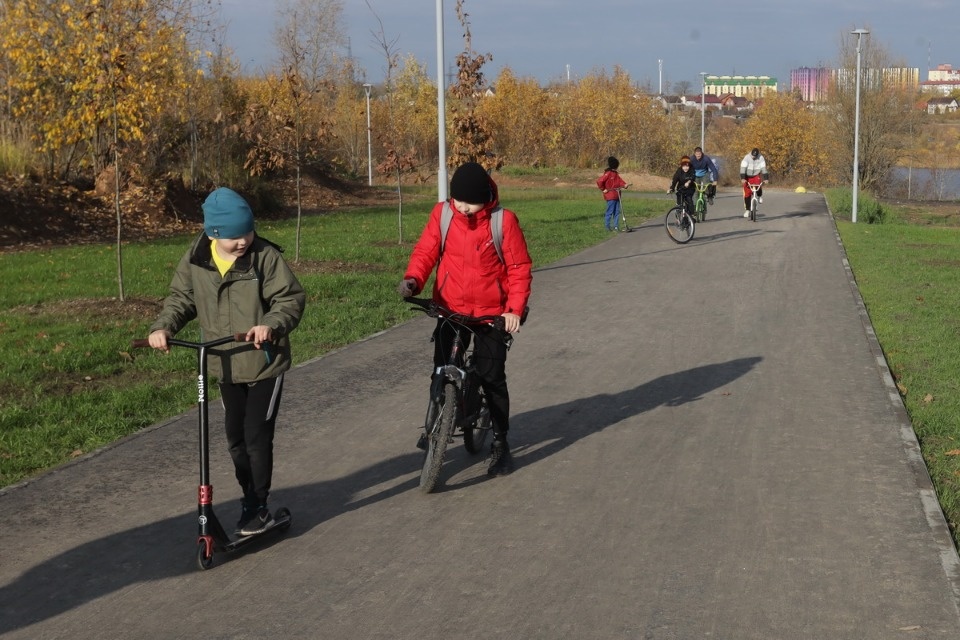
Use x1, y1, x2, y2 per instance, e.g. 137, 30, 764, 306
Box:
0, 357, 762, 634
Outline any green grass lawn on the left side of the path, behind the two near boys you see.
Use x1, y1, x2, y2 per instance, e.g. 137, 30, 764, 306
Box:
0, 189, 663, 486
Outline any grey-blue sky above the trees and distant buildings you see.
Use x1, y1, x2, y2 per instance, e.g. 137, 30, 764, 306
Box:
219, 0, 960, 92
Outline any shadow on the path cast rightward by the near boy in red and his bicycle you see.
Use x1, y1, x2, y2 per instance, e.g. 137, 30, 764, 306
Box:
437, 356, 763, 491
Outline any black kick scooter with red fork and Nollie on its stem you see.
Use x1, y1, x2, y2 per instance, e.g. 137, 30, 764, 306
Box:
131, 333, 292, 570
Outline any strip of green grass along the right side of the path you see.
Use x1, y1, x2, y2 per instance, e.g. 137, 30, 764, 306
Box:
828, 189, 960, 544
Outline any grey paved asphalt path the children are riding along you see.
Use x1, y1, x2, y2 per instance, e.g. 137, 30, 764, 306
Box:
0, 190, 960, 640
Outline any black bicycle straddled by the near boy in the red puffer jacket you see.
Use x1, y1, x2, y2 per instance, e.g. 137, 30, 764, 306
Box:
404, 297, 513, 493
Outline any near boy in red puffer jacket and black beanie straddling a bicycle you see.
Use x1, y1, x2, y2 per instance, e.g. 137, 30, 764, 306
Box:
398, 162, 533, 476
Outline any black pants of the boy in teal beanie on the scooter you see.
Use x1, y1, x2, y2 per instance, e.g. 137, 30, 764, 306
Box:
220, 374, 283, 506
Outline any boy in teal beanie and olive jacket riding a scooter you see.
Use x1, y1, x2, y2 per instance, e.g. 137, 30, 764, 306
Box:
148, 187, 306, 536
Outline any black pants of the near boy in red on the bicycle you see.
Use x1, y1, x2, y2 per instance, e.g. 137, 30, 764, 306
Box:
433, 320, 510, 439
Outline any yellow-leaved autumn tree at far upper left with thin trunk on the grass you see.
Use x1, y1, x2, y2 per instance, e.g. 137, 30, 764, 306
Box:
0, 0, 190, 301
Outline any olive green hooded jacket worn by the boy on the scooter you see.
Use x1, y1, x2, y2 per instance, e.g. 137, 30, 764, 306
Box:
150, 233, 306, 383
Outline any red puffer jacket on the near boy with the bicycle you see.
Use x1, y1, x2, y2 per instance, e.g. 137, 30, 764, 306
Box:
404, 190, 533, 316
